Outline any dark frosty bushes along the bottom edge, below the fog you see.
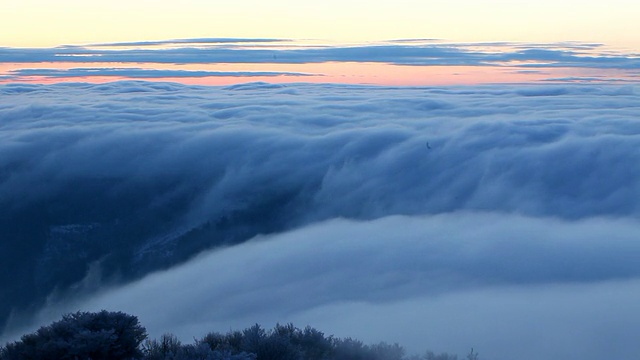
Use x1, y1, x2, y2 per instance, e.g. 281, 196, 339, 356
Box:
0, 310, 478, 360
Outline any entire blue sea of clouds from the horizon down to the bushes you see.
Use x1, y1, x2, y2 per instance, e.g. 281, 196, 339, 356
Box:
0, 82, 640, 360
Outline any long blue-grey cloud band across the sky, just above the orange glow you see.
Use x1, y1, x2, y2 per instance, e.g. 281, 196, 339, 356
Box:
0, 40, 640, 69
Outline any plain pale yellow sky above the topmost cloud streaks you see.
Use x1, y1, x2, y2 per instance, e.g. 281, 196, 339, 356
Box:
0, 0, 640, 50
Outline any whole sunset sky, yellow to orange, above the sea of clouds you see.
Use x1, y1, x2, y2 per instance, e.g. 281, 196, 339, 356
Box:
0, 0, 640, 85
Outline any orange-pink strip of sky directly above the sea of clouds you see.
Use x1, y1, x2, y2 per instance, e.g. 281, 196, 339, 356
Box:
0, 62, 626, 86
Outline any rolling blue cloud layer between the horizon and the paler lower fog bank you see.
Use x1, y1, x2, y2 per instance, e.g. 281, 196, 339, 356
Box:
5, 82, 640, 218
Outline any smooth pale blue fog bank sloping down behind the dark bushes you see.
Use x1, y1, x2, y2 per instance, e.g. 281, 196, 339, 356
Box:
8, 213, 640, 360
